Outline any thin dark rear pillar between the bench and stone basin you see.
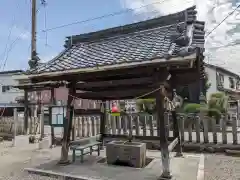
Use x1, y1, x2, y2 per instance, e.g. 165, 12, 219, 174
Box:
100, 101, 107, 149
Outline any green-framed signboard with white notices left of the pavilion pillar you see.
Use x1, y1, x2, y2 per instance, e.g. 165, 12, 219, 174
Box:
52, 106, 66, 127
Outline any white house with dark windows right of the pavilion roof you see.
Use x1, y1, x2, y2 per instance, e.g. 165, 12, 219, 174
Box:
205, 64, 240, 99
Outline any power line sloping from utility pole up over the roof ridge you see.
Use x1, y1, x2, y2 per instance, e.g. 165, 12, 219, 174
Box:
42, 0, 166, 32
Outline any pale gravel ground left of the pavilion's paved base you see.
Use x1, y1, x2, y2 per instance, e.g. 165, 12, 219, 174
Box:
0, 143, 59, 180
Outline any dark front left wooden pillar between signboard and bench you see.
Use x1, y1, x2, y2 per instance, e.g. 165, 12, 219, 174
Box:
59, 82, 76, 164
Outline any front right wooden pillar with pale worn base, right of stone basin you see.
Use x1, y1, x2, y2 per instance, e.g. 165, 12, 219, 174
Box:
156, 86, 171, 179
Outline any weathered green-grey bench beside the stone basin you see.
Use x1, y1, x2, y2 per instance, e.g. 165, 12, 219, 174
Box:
70, 136, 101, 162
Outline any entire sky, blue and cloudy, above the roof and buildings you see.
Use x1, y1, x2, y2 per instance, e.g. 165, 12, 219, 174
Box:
0, 0, 240, 73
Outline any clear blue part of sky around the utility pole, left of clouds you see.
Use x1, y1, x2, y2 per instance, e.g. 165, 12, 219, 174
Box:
0, 0, 144, 70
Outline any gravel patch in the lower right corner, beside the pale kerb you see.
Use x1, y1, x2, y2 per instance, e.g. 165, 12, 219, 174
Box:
204, 154, 240, 180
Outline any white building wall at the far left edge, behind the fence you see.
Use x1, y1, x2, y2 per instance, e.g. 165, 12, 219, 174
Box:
0, 74, 24, 103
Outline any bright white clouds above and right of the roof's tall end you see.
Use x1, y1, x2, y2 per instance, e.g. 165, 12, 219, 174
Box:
120, 0, 240, 73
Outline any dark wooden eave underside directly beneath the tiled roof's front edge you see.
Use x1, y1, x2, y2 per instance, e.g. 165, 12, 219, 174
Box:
30, 59, 195, 83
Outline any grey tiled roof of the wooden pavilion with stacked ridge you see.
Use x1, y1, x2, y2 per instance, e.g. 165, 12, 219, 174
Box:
30, 6, 205, 74
